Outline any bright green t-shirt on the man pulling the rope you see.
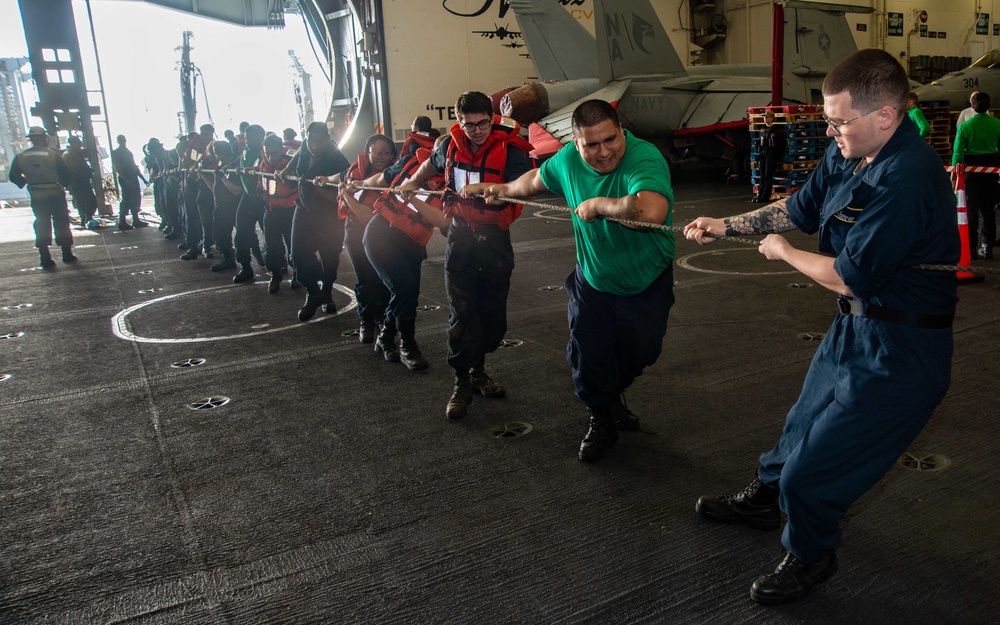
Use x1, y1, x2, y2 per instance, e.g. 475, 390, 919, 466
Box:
541, 131, 674, 295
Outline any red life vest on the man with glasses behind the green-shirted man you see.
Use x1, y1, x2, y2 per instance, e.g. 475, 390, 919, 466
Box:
445, 115, 532, 230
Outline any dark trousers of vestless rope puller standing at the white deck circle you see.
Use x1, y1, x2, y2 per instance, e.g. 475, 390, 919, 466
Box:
292, 204, 344, 295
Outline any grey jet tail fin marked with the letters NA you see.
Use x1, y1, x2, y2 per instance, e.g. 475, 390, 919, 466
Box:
594, 0, 687, 82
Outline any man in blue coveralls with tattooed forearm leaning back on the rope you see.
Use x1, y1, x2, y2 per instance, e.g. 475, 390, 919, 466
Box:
684, 50, 959, 604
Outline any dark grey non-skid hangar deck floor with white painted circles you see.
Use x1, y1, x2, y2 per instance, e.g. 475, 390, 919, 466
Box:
0, 175, 1000, 625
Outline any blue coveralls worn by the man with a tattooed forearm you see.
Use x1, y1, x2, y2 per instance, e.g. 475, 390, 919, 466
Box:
758, 118, 959, 563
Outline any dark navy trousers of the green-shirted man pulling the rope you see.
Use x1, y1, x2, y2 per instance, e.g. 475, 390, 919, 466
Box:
565, 264, 674, 407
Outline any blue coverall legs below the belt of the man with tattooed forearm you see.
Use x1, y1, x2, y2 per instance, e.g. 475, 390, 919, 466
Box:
757, 314, 952, 563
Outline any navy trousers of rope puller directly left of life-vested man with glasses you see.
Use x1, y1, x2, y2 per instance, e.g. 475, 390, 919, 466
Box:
364, 215, 427, 341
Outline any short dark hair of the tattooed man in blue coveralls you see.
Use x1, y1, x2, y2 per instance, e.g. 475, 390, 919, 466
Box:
823, 48, 910, 117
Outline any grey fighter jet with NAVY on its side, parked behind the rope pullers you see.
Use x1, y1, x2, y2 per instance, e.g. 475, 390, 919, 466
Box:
504, 0, 872, 173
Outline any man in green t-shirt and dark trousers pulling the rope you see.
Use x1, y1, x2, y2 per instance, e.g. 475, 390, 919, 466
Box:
462, 100, 674, 462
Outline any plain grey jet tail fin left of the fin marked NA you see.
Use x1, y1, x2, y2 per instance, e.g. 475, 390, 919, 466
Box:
509, 0, 597, 80
